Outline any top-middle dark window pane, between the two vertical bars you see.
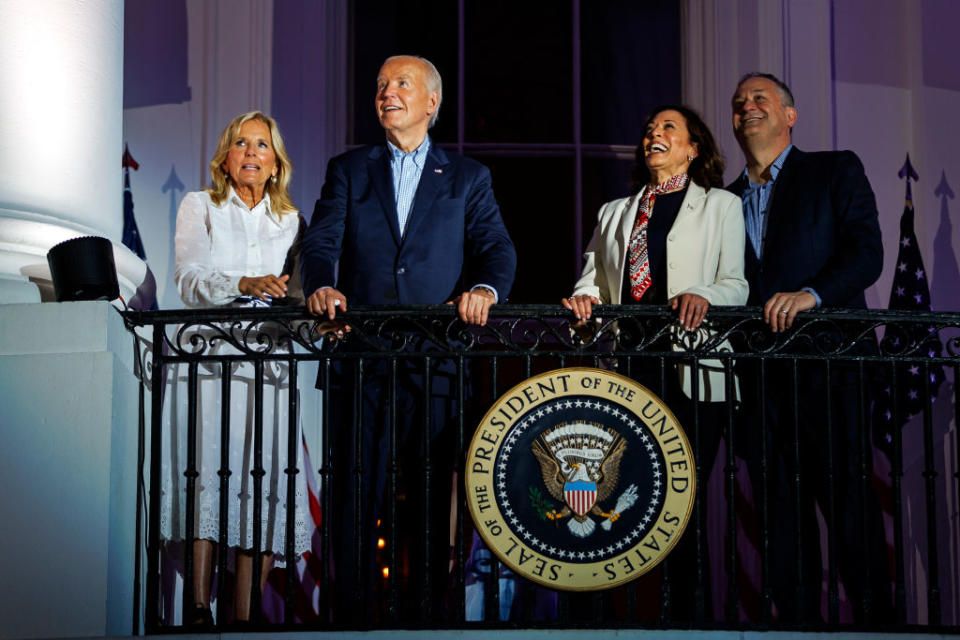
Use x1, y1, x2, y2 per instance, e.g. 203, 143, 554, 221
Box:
464, 0, 573, 142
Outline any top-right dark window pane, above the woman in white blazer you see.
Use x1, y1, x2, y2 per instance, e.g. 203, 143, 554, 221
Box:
580, 0, 681, 145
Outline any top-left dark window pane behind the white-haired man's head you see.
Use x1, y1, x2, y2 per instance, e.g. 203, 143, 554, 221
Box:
351, 0, 458, 144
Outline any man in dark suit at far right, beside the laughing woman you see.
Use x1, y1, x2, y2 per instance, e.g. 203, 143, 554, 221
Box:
727, 74, 890, 622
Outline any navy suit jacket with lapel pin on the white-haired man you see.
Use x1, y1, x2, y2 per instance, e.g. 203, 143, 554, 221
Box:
300, 144, 517, 305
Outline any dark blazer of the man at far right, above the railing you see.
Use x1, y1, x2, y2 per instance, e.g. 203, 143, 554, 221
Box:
727, 147, 883, 309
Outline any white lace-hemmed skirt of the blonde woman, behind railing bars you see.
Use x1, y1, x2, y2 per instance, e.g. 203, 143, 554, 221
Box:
160, 362, 314, 559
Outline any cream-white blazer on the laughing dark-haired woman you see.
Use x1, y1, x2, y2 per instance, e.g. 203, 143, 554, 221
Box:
573, 182, 748, 402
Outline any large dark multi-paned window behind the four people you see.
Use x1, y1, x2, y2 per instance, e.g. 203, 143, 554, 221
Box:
350, 0, 681, 303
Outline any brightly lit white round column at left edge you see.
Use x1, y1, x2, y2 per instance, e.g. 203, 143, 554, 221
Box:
0, 0, 148, 304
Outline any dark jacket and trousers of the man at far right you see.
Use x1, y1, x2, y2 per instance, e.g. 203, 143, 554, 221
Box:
727, 148, 892, 622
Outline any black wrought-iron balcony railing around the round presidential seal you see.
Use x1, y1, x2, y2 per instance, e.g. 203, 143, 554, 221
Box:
125, 305, 960, 632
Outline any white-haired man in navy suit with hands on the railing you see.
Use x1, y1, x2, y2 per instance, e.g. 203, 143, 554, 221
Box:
301, 56, 516, 616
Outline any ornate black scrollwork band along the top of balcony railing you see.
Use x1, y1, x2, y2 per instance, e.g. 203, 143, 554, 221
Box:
124, 305, 960, 362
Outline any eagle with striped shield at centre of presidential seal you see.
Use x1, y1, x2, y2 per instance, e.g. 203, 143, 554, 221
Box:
531, 423, 627, 538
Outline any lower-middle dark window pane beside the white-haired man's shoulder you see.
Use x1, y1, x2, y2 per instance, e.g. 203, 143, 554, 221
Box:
468, 155, 576, 304
